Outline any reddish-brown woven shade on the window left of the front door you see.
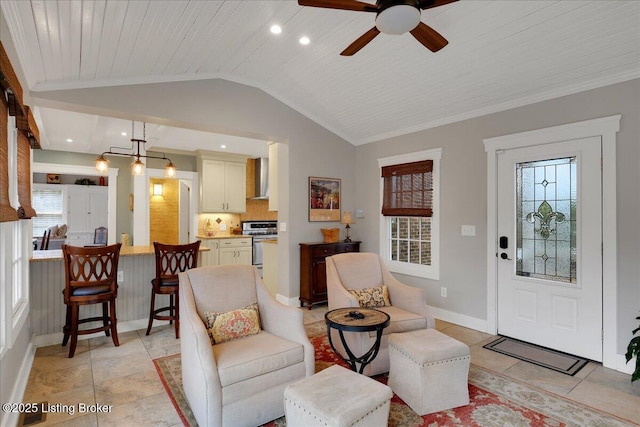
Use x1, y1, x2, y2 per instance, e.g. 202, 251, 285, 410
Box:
382, 160, 433, 217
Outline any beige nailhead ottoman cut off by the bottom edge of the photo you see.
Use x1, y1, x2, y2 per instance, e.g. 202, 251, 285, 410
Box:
284, 365, 393, 427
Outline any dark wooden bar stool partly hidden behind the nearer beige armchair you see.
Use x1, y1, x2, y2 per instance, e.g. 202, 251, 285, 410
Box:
147, 240, 200, 338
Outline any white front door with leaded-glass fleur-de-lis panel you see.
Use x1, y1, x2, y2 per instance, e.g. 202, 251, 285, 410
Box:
496, 137, 602, 361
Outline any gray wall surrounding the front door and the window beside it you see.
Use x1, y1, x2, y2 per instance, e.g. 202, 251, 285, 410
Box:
353, 80, 640, 353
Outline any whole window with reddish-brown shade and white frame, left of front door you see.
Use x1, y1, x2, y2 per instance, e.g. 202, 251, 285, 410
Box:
378, 149, 442, 279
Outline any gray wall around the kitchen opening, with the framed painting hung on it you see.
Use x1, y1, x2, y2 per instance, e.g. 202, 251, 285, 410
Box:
32, 79, 356, 298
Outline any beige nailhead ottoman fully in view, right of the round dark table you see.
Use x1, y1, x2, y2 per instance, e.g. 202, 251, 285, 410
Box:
388, 329, 471, 415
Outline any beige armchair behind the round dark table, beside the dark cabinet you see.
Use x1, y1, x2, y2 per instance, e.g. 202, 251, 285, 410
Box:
326, 252, 435, 376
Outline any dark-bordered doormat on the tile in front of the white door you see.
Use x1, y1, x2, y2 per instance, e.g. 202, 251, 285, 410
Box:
483, 337, 589, 376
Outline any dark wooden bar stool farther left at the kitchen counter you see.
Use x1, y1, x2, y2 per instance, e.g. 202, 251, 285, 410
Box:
62, 243, 122, 357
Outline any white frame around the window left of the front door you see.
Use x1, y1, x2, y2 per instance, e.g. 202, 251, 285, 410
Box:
378, 148, 442, 280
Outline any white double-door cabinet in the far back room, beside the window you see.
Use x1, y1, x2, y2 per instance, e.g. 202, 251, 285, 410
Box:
67, 185, 109, 236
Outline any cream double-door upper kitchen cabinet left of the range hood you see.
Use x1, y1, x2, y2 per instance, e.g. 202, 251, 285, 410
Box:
199, 156, 247, 213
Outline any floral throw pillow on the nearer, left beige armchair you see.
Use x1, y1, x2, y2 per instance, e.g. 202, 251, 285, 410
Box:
204, 303, 260, 345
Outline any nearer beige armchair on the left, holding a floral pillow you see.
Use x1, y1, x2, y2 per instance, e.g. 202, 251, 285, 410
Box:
178, 265, 315, 427
